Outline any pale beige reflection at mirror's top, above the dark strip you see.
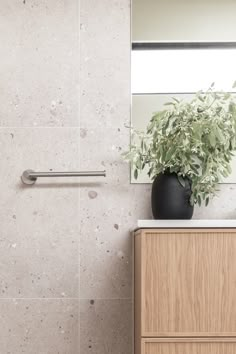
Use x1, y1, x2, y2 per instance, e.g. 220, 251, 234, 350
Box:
132, 0, 236, 42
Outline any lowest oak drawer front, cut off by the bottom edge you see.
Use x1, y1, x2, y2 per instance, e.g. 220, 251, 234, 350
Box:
142, 339, 236, 354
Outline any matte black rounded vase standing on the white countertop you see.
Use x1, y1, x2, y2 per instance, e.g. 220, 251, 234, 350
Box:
152, 172, 193, 219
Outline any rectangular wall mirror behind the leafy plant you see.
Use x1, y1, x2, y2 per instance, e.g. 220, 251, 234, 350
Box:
131, 0, 236, 183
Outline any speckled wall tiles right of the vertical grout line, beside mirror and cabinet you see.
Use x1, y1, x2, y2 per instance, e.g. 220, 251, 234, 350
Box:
80, 0, 236, 354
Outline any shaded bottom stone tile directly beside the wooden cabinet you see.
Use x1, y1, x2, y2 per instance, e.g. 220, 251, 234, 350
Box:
80, 299, 133, 354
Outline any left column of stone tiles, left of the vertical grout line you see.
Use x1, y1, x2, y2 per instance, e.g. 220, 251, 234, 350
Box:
0, 0, 80, 354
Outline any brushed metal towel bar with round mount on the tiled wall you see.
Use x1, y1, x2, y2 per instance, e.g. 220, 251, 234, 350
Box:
21, 170, 106, 184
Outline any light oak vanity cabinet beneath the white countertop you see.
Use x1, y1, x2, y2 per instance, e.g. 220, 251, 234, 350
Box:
134, 228, 236, 354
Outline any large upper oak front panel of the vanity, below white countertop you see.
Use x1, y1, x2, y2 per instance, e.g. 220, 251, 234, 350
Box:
141, 230, 236, 336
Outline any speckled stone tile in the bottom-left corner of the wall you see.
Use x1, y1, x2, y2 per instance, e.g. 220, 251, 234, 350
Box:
0, 300, 79, 354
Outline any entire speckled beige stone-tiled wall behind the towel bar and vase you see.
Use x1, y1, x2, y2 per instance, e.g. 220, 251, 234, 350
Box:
0, 0, 236, 354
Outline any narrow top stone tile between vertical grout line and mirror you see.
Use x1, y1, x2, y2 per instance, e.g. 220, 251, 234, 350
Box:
80, 0, 131, 131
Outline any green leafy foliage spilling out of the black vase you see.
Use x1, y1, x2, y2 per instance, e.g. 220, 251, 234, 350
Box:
123, 83, 236, 205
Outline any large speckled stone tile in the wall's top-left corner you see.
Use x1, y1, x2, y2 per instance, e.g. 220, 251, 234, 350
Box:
0, 0, 79, 126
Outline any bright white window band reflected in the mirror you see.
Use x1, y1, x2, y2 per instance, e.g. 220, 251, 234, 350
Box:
132, 46, 236, 94
